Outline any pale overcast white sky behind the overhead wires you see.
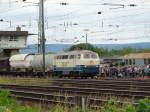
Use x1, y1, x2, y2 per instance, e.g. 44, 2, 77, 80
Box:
0, 0, 150, 44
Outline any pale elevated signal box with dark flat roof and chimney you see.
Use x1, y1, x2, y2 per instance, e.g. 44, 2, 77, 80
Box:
0, 28, 28, 57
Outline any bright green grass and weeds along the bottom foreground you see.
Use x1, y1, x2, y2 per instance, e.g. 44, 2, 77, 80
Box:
0, 90, 150, 112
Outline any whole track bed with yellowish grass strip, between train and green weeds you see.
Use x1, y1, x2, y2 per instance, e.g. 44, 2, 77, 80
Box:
0, 77, 150, 112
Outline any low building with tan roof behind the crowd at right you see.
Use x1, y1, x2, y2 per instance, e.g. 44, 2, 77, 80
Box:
124, 53, 150, 66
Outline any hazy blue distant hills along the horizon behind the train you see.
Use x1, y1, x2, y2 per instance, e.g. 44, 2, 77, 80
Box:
20, 43, 150, 53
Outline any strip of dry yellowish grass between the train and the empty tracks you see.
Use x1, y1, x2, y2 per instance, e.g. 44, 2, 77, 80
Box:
0, 76, 150, 86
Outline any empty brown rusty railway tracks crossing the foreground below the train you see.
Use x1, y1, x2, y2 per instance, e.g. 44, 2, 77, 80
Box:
0, 79, 150, 107
